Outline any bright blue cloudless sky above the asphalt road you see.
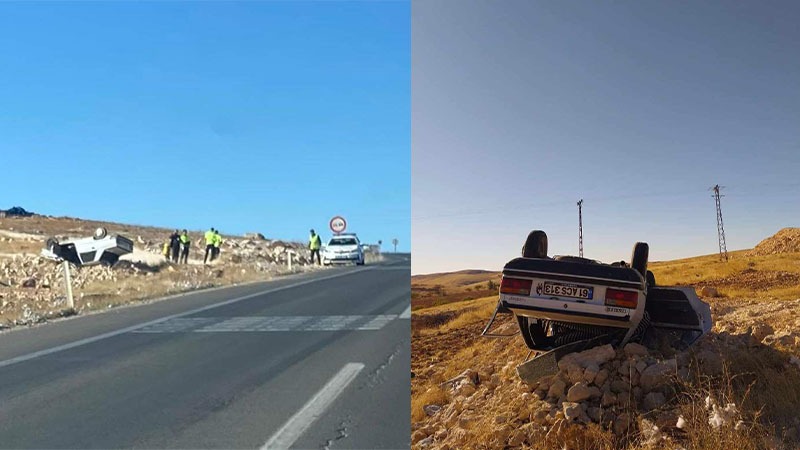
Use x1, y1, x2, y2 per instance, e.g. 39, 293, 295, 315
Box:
0, 1, 411, 251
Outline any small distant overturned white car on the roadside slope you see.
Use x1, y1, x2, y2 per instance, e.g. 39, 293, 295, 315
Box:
41, 228, 133, 266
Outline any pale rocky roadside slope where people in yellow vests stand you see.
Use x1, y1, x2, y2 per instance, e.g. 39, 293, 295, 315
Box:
0, 216, 382, 329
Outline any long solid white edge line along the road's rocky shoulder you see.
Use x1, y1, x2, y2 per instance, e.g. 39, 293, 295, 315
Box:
0, 268, 370, 367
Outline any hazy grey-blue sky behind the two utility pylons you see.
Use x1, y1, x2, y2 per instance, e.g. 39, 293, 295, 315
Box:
412, 0, 800, 273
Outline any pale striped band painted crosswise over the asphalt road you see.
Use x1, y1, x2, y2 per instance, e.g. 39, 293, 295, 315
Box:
133, 312, 405, 333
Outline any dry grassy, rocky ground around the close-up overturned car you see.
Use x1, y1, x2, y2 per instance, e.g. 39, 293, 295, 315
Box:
412, 231, 800, 450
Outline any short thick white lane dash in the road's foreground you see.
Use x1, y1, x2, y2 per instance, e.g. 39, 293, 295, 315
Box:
261, 363, 364, 450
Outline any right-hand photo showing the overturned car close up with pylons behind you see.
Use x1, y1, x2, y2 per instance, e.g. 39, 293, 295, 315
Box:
411, 0, 800, 450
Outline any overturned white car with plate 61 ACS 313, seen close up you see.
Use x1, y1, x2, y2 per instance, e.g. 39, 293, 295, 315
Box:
484, 230, 712, 351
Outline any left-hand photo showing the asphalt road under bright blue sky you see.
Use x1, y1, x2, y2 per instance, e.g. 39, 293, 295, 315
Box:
0, 1, 411, 449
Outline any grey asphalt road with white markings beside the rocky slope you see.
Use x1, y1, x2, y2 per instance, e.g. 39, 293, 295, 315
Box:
0, 255, 411, 449
